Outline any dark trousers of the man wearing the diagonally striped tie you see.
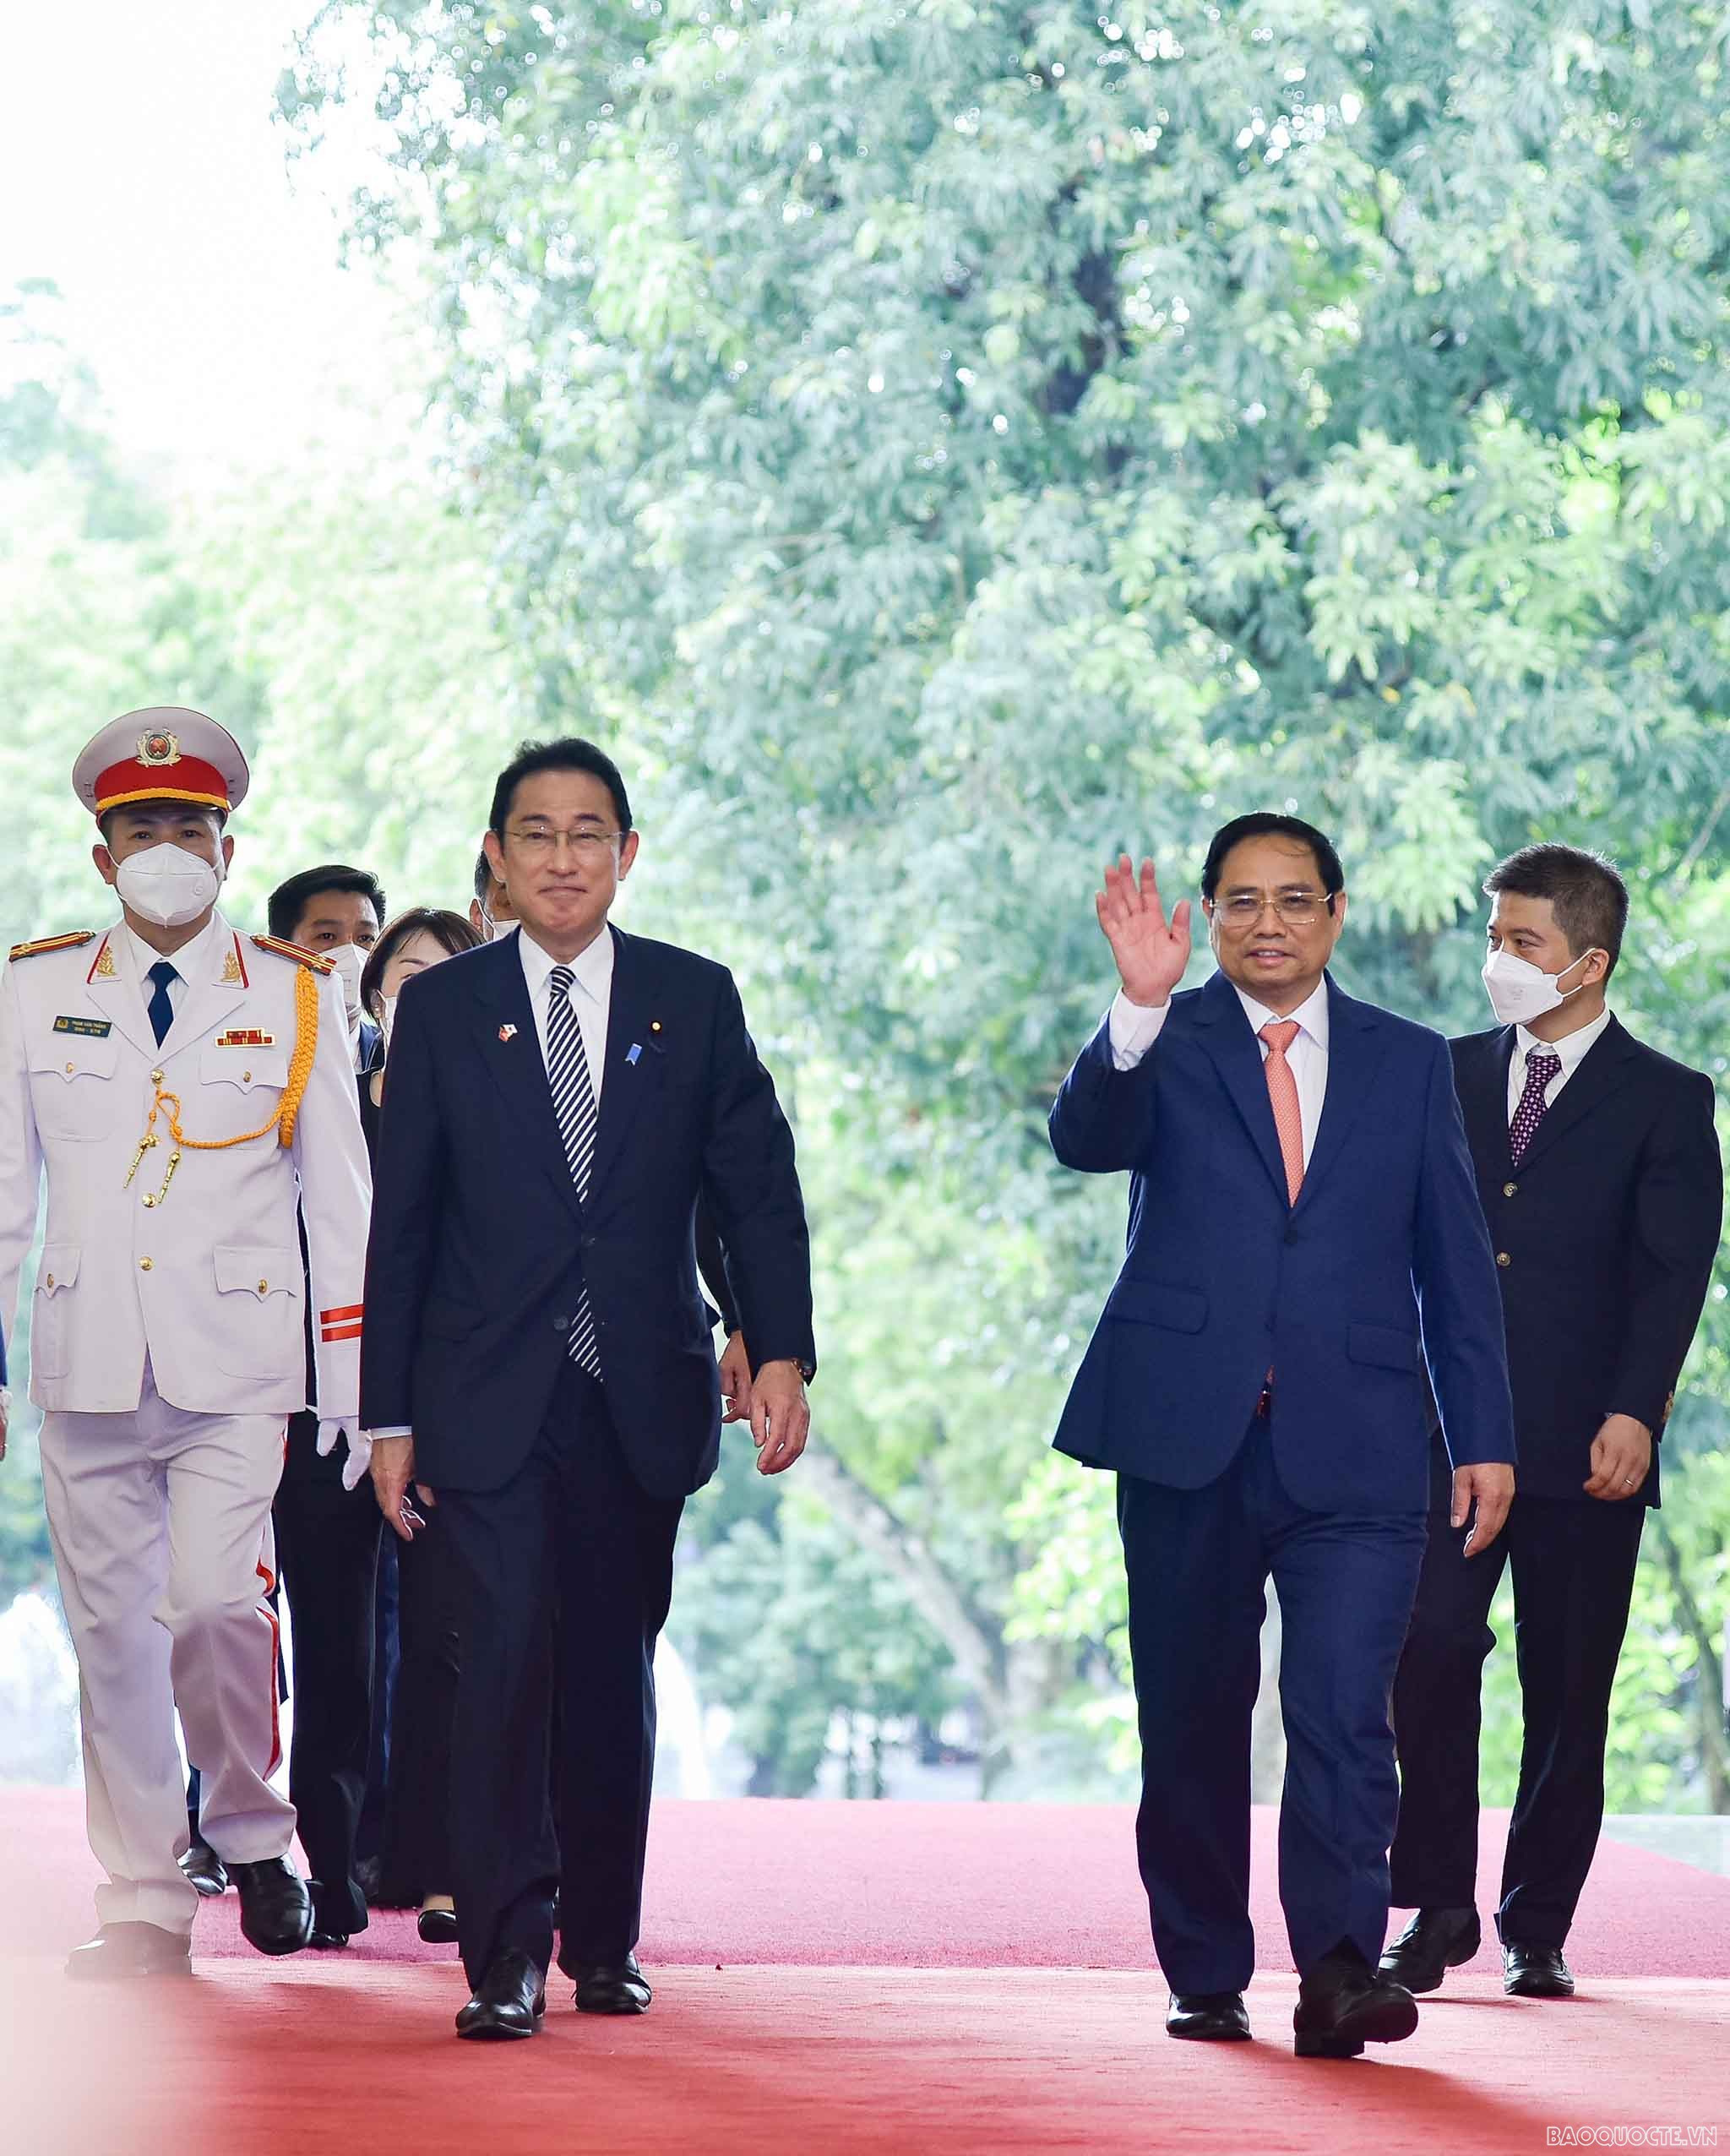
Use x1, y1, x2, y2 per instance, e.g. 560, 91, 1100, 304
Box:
438, 1364, 683, 1984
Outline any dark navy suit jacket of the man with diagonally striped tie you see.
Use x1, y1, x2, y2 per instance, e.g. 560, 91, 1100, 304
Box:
360, 929, 814, 1496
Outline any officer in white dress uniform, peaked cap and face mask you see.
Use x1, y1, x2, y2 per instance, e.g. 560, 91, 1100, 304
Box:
0, 707, 371, 1977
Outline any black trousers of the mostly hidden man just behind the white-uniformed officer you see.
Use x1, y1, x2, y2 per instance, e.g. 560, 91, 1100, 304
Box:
271, 1414, 384, 1932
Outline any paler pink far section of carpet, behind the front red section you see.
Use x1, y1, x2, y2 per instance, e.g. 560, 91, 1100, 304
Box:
0, 1789, 1730, 1979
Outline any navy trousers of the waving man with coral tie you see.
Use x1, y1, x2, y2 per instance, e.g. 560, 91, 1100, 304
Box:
1118, 1407, 1424, 1992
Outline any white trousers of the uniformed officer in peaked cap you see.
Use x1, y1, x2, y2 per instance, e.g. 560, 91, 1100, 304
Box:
41, 1367, 295, 1932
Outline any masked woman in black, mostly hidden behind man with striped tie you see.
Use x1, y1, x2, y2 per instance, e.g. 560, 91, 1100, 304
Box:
360, 906, 481, 1942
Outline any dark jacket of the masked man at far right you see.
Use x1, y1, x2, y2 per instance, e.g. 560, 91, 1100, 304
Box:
1452, 1018, 1723, 1505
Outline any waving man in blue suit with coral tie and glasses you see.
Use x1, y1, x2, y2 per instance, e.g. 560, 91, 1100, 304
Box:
1052, 815, 1515, 2057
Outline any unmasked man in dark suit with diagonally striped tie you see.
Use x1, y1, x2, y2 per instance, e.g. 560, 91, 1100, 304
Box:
362, 739, 814, 2038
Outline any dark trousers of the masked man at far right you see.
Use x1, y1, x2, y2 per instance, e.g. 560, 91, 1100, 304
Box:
1392, 1494, 1646, 1946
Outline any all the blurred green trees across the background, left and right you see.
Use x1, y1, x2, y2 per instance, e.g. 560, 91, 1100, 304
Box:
0, 0, 1730, 1811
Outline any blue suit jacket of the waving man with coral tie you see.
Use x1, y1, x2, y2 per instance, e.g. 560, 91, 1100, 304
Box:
1052, 975, 1515, 1514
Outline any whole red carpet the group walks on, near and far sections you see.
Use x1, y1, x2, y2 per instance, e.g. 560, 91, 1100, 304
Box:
0, 1792, 1730, 2156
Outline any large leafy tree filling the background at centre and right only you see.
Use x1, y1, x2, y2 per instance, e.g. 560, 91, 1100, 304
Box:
282, 0, 1730, 1800
